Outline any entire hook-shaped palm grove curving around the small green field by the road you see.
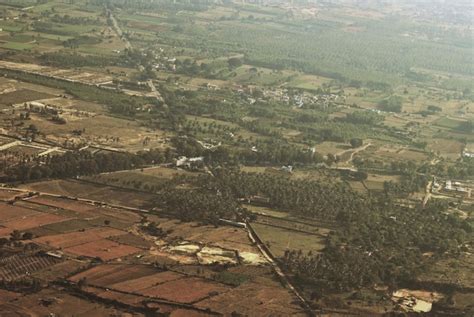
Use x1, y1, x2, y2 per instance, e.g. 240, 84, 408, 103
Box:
151, 168, 466, 291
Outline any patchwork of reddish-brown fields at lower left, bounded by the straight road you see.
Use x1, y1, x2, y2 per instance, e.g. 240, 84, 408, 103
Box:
0, 185, 301, 313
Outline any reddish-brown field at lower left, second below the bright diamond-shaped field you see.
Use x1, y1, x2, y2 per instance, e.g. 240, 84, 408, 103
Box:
69, 264, 157, 287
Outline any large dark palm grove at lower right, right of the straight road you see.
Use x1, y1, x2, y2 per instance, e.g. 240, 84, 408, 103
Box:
283, 200, 472, 291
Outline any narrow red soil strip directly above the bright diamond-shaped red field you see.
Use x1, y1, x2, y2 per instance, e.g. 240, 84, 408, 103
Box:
33, 227, 125, 248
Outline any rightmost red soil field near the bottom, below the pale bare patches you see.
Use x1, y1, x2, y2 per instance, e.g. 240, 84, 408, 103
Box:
140, 277, 230, 303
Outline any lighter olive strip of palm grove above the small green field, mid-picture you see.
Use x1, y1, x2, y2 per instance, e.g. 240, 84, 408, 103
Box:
193, 168, 366, 221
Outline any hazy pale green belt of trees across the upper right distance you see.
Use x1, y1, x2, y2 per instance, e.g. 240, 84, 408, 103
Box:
96, 0, 474, 83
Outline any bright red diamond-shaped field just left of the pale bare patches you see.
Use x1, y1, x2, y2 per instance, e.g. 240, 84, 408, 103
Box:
64, 239, 142, 261
